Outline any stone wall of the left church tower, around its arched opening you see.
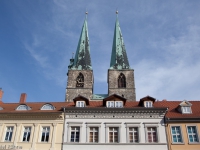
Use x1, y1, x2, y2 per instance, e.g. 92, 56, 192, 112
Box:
65, 70, 93, 102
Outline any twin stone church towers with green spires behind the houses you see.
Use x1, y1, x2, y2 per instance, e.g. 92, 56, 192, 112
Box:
65, 11, 136, 102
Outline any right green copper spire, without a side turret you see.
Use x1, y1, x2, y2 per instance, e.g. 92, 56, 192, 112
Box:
110, 11, 130, 69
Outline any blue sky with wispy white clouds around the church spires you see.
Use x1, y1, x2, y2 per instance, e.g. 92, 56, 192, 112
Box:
0, 0, 200, 102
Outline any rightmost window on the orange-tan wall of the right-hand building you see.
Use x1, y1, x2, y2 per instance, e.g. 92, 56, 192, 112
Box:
187, 126, 199, 143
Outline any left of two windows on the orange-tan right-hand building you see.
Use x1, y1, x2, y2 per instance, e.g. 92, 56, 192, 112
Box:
171, 126, 182, 143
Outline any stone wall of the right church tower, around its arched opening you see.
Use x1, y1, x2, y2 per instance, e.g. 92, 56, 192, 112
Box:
108, 69, 136, 101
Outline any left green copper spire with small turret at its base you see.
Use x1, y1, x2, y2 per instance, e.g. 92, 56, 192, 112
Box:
68, 12, 92, 70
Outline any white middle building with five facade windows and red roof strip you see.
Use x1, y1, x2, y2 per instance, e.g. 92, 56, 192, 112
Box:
63, 96, 167, 150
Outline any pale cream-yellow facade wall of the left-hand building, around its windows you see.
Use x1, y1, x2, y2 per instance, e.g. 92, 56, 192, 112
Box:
0, 114, 64, 150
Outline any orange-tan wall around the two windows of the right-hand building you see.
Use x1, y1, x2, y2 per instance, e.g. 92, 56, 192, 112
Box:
166, 123, 200, 150
